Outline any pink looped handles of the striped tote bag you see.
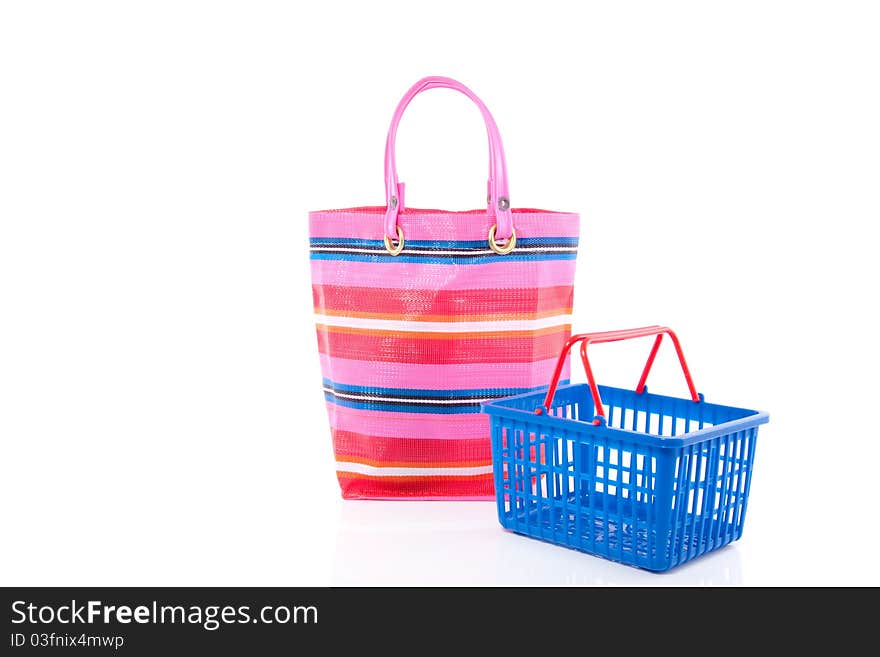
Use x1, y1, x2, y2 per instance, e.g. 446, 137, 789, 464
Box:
385, 76, 513, 240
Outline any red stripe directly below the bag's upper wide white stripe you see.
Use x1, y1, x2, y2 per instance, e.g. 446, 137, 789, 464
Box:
317, 328, 569, 365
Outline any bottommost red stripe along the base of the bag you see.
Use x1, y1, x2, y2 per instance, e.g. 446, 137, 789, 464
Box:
337, 472, 495, 500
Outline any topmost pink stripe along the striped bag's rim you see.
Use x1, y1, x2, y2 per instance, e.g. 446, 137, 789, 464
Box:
309, 208, 579, 240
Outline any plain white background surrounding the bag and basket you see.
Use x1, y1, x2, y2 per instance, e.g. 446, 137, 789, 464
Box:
0, 0, 880, 585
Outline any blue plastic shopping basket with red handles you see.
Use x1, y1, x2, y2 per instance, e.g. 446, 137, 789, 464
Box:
483, 326, 768, 571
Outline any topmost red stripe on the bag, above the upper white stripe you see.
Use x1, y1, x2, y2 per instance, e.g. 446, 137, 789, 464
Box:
312, 285, 573, 317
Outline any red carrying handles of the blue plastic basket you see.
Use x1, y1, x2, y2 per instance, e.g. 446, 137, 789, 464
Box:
535, 326, 700, 424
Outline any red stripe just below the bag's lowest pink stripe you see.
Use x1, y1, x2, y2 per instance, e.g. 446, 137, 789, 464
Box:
333, 429, 492, 467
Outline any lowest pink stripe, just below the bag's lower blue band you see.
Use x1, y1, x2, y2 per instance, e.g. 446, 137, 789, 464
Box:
327, 402, 489, 440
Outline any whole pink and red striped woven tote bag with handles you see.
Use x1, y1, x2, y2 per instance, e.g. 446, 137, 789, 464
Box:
309, 77, 578, 499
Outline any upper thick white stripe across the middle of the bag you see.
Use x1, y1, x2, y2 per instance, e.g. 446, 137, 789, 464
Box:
315, 312, 571, 333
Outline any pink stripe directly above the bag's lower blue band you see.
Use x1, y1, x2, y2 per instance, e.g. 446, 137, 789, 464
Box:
321, 354, 569, 390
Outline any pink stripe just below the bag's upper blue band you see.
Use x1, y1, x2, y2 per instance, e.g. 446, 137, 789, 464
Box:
311, 260, 575, 290
